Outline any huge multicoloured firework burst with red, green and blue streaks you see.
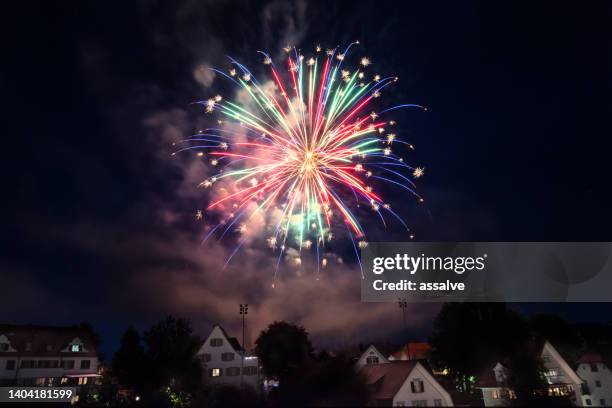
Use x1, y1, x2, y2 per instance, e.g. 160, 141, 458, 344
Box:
175, 42, 426, 278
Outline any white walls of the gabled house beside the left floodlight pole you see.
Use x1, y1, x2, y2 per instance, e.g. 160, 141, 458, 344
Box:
196, 326, 259, 390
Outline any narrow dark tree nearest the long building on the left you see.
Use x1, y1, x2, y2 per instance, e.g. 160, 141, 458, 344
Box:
112, 326, 147, 392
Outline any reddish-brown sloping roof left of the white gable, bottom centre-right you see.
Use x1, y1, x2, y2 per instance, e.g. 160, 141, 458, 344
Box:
360, 361, 418, 399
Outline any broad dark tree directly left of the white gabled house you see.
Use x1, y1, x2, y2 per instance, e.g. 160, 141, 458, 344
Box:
143, 316, 202, 392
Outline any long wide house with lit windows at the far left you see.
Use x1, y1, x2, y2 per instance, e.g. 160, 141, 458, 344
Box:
0, 324, 100, 402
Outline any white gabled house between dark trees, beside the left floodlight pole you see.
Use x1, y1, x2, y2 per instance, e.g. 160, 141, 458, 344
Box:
196, 324, 260, 390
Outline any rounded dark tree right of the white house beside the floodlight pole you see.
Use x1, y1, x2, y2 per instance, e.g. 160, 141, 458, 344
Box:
255, 322, 313, 386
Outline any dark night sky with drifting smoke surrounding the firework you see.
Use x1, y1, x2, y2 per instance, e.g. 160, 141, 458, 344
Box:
0, 0, 612, 353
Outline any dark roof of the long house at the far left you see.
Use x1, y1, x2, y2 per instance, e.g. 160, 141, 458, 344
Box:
0, 324, 97, 357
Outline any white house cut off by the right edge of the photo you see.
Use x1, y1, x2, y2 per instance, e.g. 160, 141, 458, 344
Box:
576, 351, 612, 407
